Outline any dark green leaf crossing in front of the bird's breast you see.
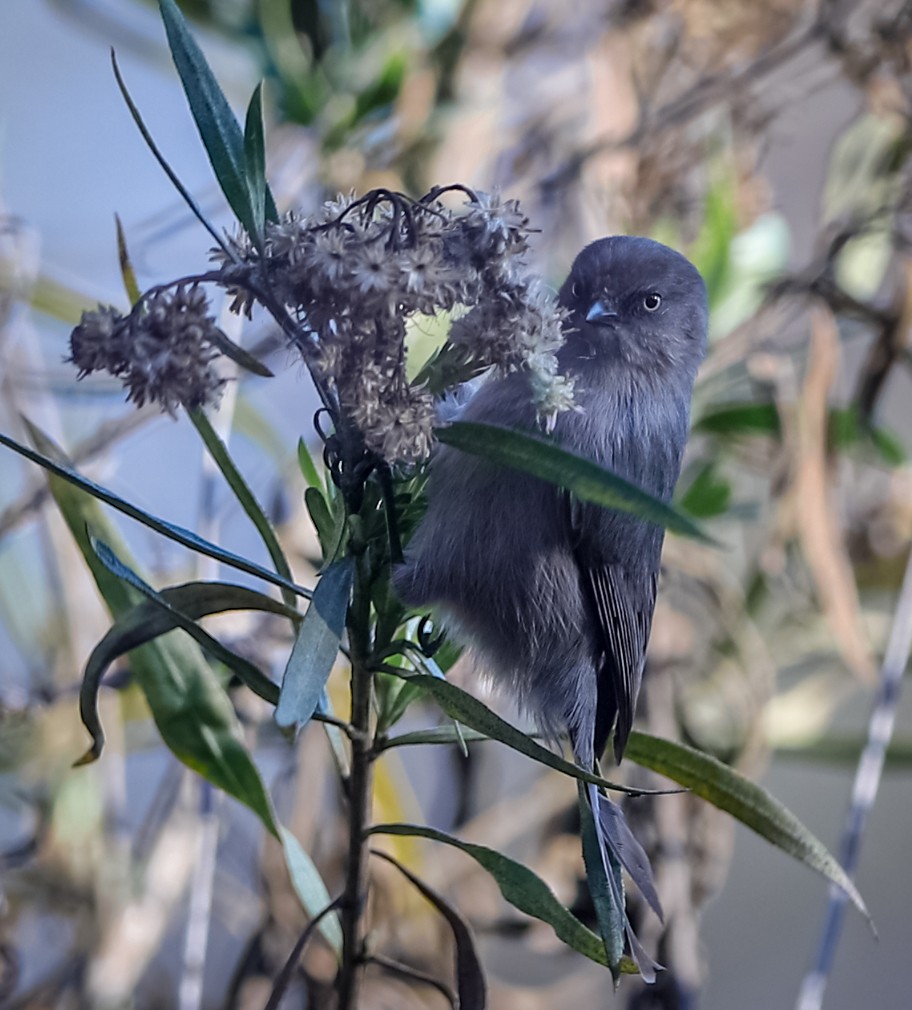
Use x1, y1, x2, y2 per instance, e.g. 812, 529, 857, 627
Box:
435, 421, 712, 542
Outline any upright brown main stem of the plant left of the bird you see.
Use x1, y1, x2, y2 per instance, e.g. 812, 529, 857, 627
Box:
338, 544, 374, 1010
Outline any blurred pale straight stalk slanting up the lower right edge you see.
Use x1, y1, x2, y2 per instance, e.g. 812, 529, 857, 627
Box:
795, 552, 912, 1010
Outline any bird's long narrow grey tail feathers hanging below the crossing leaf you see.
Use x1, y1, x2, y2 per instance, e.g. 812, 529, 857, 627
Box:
580, 783, 664, 982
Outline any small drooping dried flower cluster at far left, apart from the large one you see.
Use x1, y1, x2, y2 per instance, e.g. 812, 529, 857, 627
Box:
70, 284, 225, 414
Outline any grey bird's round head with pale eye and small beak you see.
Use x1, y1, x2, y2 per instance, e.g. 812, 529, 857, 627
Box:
560, 235, 709, 373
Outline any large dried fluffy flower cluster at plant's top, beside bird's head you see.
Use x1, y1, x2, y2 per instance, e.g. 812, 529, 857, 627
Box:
215, 191, 572, 462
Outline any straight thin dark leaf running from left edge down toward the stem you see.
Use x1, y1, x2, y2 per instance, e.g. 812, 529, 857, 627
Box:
0, 428, 311, 599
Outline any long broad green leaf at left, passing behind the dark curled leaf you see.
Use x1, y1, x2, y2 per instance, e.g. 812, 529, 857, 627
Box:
29, 425, 341, 954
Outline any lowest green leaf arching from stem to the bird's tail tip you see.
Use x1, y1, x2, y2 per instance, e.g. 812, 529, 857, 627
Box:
368, 824, 636, 975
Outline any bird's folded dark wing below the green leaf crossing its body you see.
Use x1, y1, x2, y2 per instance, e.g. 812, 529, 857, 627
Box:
570, 492, 661, 762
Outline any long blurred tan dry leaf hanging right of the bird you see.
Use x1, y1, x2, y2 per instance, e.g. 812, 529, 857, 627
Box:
792, 306, 875, 684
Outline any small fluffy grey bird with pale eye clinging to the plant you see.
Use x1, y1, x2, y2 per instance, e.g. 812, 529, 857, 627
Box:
395, 236, 708, 977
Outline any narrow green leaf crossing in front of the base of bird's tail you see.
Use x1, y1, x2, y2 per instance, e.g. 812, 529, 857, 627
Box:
388, 668, 668, 796
